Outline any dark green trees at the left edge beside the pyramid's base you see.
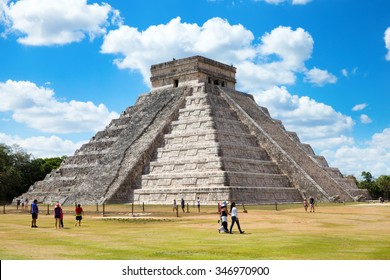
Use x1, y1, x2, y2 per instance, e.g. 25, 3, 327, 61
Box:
0, 144, 64, 202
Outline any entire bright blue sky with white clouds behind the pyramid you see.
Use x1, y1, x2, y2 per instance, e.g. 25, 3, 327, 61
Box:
0, 0, 390, 176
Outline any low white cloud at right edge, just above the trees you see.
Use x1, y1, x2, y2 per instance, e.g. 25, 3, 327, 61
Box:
321, 128, 390, 177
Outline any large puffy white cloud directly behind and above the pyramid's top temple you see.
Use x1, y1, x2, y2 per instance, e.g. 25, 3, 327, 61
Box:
101, 17, 255, 84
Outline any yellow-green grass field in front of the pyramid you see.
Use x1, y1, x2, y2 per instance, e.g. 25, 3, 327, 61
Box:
0, 203, 390, 260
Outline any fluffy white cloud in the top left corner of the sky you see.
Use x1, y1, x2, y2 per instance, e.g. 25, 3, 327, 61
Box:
2, 0, 119, 46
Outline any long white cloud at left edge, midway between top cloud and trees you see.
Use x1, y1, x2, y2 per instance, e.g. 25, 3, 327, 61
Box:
0, 80, 118, 133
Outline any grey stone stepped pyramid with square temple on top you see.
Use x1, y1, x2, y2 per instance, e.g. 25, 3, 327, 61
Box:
18, 56, 369, 204
